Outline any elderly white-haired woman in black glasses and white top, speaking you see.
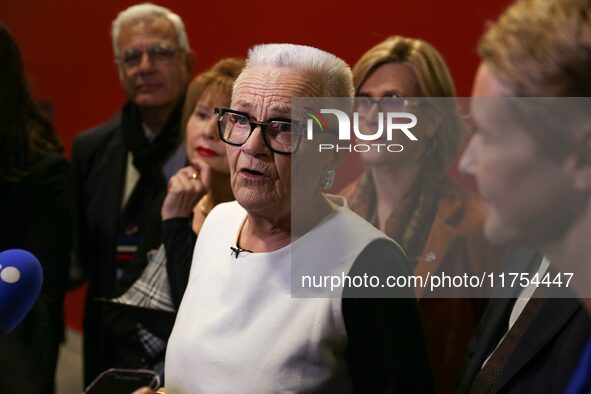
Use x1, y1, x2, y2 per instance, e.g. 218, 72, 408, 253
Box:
165, 44, 433, 393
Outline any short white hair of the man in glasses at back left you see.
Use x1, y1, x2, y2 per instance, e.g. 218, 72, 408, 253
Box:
111, 3, 190, 58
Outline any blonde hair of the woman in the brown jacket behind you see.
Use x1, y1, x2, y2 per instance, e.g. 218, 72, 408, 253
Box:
353, 36, 464, 167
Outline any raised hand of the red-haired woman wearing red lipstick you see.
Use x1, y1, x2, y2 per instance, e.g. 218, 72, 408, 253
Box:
161, 166, 210, 220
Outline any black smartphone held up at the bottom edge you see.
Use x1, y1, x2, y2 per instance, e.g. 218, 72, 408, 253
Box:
84, 368, 160, 394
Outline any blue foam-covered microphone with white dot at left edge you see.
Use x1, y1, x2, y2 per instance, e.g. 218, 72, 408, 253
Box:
0, 249, 43, 335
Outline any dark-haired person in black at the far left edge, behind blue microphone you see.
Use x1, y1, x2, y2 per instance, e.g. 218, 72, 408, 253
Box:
0, 25, 73, 393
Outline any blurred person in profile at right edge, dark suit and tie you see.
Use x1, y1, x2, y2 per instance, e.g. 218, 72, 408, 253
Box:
458, 0, 591, 393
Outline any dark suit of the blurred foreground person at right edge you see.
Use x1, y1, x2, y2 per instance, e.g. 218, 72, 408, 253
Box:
457, 248, 591, 393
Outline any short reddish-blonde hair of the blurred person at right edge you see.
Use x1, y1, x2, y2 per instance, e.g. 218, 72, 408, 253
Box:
478, 0, 591, 159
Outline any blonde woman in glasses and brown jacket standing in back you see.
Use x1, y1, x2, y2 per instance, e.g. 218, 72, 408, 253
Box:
340, 36, 499, 393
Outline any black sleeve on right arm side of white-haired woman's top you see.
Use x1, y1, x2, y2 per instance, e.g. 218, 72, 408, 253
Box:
342, 239, 435, 393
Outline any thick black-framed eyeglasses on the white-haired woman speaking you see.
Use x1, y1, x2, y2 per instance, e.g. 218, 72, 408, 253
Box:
214, 108, 303, 154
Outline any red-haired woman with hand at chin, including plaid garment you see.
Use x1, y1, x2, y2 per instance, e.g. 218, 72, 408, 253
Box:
105, 58, 244, 381
